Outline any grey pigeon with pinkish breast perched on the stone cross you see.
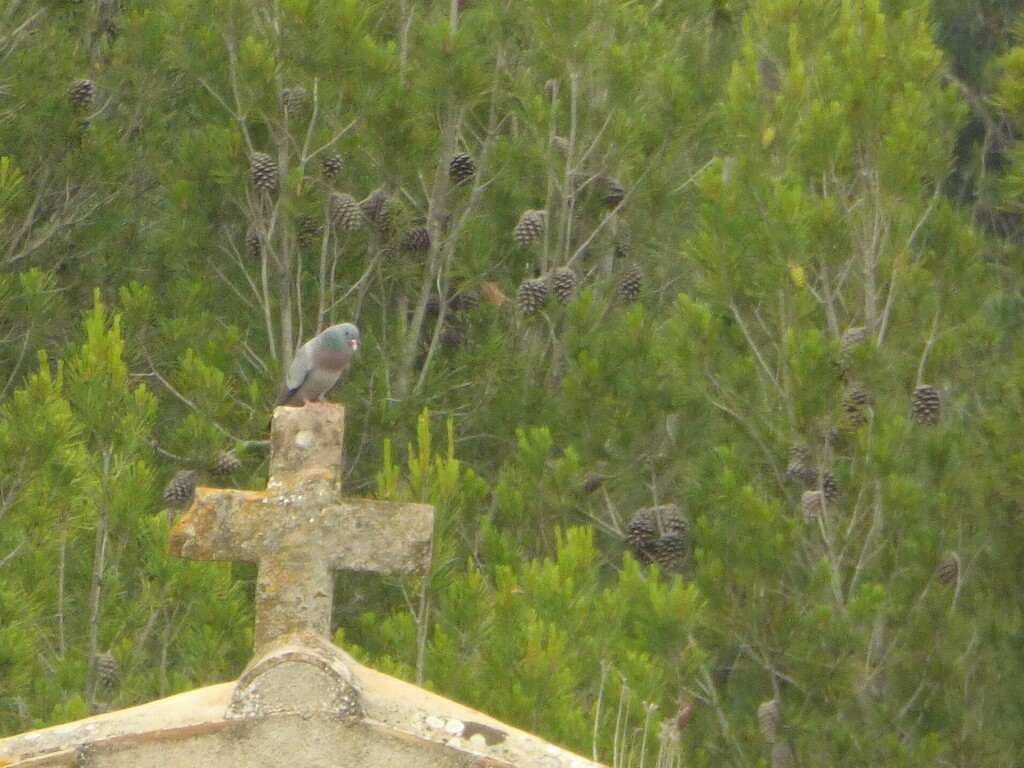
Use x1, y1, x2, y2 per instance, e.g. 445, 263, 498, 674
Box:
275, 323, 359, 406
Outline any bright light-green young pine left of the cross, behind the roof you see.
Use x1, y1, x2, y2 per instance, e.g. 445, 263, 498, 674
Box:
0, 296, 246, 730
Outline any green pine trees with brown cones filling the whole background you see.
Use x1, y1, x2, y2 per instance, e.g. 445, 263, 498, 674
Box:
0, 0, 1024, 768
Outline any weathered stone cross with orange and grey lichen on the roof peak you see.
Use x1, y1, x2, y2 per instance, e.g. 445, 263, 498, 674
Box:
170, 407, 433, 656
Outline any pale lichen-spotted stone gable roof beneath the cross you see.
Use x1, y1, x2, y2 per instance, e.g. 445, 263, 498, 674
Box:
0, 646, 597, 768
